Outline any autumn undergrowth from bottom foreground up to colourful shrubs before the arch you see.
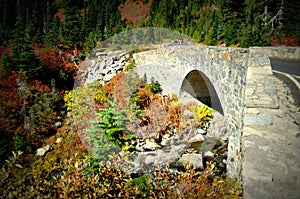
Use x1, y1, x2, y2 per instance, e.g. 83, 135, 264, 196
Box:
0, 73, 242, 199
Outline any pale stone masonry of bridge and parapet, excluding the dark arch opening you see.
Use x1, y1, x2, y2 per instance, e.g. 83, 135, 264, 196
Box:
133, 45, 300, 198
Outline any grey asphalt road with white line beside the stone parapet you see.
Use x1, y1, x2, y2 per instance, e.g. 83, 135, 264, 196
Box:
270, 58, 300, 105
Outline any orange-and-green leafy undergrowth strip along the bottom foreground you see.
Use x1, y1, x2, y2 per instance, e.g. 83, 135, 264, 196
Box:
0, 152, 242, 199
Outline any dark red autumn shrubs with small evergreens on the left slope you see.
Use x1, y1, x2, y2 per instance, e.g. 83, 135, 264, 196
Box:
0, 46, 77, 164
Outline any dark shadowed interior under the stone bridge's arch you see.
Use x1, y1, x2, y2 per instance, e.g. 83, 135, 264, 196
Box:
180, 70, 224, 115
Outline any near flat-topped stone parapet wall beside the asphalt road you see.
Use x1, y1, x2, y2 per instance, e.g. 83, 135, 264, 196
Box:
240, 47, 300, 198
